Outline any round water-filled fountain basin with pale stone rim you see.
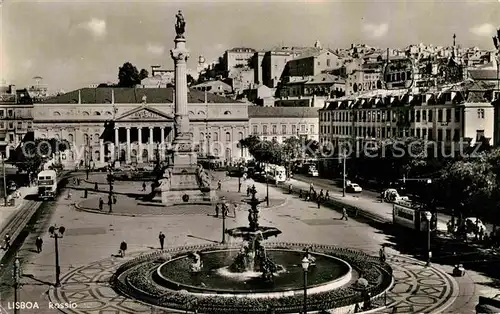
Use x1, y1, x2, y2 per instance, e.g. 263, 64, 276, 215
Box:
153, 249, 352, 298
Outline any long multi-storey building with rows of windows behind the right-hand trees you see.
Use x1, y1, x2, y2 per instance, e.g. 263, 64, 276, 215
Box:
319, 85, 495, 149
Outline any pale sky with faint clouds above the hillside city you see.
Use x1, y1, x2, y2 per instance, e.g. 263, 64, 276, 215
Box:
0, 0, 500, 91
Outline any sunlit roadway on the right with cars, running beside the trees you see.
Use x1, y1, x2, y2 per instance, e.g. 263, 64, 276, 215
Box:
292, 174, 451, 231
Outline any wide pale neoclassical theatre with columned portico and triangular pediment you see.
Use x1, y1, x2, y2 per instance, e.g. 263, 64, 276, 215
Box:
33, 88, 249, 167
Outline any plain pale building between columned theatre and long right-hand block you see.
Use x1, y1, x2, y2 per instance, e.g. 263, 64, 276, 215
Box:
248, 106, 319, 143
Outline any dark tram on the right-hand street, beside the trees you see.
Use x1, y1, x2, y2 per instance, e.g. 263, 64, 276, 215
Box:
392, 200, 437, 232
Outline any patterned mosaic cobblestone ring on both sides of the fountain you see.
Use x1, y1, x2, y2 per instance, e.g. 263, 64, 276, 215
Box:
49, 251, 457, 314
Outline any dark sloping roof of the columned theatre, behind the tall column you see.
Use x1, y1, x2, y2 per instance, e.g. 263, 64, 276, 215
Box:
42, 87, 237, 104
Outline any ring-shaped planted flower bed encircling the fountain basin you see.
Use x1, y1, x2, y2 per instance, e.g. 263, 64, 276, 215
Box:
111, 243, 392, 313
